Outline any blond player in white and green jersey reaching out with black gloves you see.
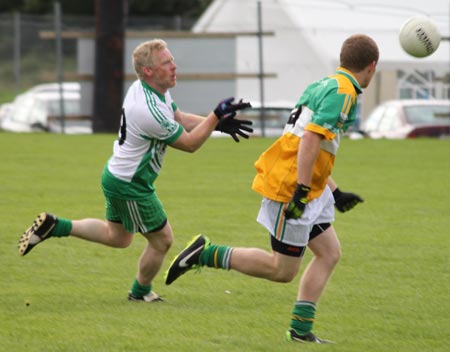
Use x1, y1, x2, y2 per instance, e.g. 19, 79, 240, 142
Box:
19, 39, 253, 302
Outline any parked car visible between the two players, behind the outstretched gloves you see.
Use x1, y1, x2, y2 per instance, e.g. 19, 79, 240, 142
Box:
213, 101, 295, 137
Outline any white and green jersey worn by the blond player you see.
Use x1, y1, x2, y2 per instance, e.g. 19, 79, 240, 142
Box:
102, 81, 183, 199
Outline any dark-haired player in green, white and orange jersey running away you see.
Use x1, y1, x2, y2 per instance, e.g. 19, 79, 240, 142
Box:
166, 35, 379, 343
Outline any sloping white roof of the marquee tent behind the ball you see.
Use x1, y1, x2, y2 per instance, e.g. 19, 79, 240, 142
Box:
194, 0, 450, 67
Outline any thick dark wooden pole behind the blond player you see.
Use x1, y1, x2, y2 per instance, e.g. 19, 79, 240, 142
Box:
93, 0, 127, 133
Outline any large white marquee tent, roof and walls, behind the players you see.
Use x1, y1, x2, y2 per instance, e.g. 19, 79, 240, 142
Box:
194, 0, 450, 113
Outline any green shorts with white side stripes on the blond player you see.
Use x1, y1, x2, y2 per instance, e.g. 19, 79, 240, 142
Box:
105, 193, 167, 233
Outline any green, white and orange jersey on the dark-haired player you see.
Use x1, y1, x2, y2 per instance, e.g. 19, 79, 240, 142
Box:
253, 67, 361, 203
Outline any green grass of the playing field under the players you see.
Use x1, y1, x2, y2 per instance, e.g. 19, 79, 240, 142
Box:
0, 133, 450, 352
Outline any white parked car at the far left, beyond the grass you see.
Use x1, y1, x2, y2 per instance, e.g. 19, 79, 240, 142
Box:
0, 82, 92, 134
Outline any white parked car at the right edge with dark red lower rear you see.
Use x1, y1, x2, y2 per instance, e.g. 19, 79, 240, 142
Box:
362, 99, 450, 139
